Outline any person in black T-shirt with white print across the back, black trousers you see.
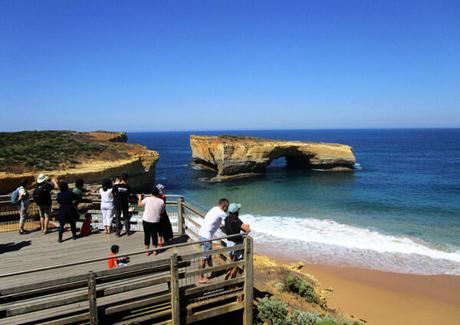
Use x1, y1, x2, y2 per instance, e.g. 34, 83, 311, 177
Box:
112, 174, 131, 237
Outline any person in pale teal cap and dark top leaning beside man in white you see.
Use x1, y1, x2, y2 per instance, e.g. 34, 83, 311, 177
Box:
225, 203, 251, 280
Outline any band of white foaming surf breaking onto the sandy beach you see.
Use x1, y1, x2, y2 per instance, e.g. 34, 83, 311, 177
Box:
241, 214, 460, 274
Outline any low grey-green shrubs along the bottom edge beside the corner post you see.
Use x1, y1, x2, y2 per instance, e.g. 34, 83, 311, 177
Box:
257, 297, 362, 325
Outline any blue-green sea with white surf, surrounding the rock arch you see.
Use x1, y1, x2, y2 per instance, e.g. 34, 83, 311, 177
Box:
128, 129, 460, 275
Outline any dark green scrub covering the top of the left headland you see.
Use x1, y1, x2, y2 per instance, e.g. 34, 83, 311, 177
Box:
0, 131, 129, 172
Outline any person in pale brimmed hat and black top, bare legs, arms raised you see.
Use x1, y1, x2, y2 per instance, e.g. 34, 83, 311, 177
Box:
32, 174, 58, 234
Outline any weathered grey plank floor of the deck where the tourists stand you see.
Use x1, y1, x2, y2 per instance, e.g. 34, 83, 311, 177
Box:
0, 231, 199, 289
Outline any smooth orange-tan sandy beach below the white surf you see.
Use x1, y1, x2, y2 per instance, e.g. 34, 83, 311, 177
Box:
255, 246, 460, 325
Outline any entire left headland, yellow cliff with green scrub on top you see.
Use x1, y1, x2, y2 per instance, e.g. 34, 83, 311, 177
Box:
0, 131, 160, 194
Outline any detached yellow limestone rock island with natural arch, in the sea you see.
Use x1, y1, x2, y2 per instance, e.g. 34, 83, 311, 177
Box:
190, 135, 356, 180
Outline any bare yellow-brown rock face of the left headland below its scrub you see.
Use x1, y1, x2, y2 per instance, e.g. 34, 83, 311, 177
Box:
0, 131, 160, 194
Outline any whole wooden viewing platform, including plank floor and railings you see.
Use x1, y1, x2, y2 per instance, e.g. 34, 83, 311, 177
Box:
0, 196, 253, 324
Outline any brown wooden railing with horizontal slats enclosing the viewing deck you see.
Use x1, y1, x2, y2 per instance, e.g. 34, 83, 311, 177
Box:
0, 196, 253, 325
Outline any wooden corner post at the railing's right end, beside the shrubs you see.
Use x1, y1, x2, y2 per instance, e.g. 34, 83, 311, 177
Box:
243, 236, 254, 325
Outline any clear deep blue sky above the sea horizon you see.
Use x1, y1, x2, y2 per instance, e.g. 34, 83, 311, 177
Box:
0, 0, 460, 131
